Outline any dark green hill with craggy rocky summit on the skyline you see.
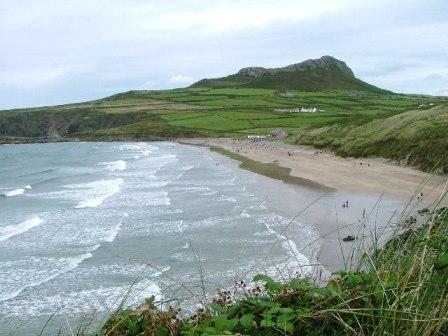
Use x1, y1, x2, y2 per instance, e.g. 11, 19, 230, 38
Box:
192, 56, 386, 93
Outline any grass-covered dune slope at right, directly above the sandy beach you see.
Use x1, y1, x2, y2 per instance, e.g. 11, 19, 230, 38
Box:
289, 105, 448, 173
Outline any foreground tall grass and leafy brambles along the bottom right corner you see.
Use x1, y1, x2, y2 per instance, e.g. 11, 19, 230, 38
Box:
98, 201, 448, 336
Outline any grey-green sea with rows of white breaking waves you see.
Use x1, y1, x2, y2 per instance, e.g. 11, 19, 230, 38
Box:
0, 142, 403, 335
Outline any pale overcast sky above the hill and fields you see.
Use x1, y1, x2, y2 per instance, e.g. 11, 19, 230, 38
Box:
0, 0, 448, 109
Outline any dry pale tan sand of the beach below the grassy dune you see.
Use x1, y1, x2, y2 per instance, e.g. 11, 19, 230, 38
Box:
177, 138, 448, 206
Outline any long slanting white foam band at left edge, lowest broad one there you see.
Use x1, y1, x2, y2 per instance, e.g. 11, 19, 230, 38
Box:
0, 251, 93, 302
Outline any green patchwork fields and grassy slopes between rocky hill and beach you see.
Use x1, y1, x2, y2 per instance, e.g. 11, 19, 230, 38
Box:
0, 87, 448, 171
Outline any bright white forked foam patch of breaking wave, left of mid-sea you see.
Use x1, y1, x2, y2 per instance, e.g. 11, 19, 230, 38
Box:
71, 178, 123, 209
